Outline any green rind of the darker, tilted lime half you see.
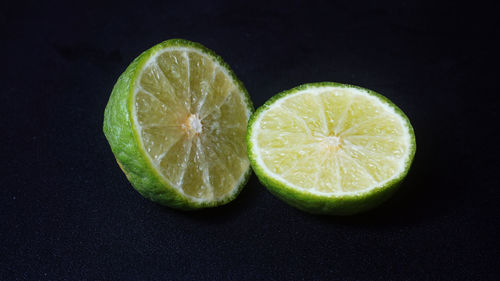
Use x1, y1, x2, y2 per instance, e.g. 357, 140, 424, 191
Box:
103, 39, 254, 210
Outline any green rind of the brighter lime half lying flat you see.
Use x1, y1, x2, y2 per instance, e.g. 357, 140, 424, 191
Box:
247, 82, 416, 215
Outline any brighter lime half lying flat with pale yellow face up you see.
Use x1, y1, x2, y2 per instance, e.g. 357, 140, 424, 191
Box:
247, 82, 416, 214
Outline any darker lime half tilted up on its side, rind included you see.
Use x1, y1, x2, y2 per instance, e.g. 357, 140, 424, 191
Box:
104, 39, 253, 209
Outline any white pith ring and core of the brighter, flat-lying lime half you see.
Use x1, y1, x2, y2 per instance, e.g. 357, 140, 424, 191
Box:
249, 86, 412, 197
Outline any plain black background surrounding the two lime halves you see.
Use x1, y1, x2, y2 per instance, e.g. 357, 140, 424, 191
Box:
0, 0, 500, 280
